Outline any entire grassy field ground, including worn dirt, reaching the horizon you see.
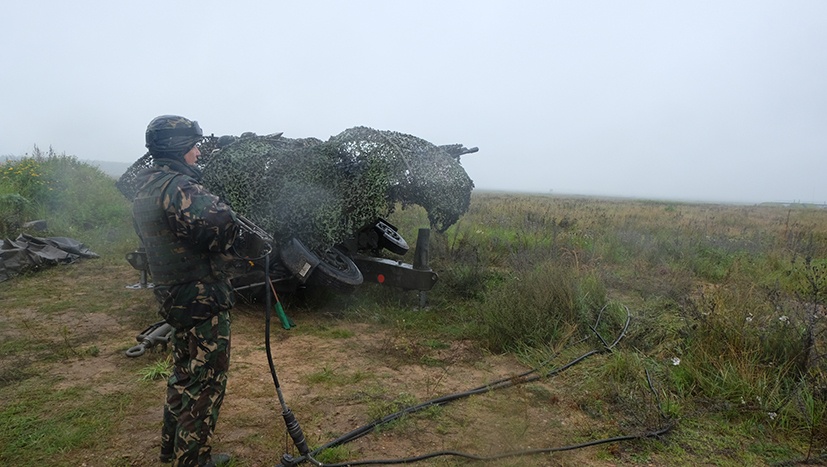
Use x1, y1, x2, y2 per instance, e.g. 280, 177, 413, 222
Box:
0, 155, 827, 466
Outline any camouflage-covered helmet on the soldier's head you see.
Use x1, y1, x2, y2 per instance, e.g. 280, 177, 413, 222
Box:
146, 115, 204, 159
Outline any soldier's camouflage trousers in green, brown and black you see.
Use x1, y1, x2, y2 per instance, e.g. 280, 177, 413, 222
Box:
161, 310, 230, 467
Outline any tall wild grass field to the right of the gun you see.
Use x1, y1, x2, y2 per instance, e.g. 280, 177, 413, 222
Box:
384, 193, 827, 460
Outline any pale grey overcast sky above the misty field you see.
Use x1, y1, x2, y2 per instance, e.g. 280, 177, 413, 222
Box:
0, 0, 827, 203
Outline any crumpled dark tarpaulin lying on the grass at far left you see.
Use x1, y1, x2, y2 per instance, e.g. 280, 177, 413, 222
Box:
0, 234, 98, 282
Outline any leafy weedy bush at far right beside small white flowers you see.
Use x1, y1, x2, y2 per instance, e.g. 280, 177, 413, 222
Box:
675, 284, 807, 412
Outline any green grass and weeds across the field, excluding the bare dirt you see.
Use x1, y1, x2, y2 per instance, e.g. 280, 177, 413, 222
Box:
0, 158, 827, 465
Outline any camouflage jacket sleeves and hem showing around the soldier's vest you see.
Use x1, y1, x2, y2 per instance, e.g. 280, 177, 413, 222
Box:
135, 159, 239, 330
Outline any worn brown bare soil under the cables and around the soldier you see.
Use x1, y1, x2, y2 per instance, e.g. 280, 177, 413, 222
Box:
0, 262, 660, 467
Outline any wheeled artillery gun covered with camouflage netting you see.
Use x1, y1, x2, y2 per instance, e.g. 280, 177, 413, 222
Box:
116, 127, 477, 308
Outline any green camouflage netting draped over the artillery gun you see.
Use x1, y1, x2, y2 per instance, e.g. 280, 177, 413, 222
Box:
117, 127, 476, 249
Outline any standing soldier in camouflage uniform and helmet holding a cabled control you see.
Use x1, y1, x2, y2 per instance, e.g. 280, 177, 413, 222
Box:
132, 115, 239, 467
